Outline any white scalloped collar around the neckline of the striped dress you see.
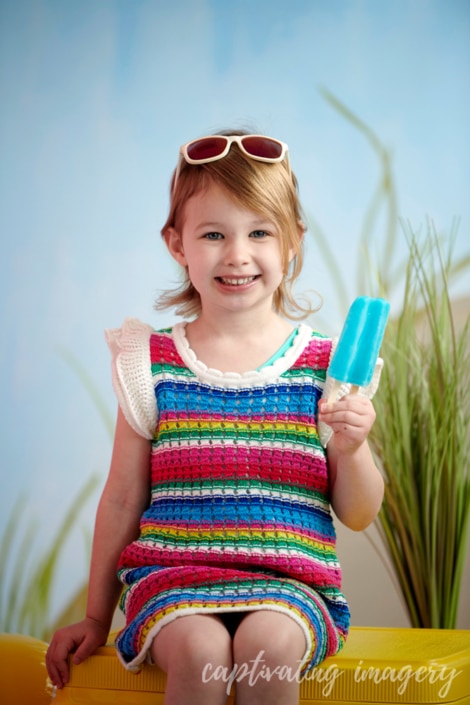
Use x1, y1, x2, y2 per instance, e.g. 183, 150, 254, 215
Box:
172, 321, 312, 387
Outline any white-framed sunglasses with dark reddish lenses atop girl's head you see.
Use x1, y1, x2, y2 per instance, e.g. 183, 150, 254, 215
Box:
173, 135, 290, 189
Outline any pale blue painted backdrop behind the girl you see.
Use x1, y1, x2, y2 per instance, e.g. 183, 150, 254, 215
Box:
0, 0, 470, 628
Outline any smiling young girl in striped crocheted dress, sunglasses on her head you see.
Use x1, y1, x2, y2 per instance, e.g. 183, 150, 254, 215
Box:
47, 132, 383, 705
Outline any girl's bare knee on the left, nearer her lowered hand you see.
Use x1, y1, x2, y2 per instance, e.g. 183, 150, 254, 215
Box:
151, 614, 232, 705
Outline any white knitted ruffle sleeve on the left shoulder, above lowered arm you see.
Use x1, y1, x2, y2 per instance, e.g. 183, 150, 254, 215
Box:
105, 318, 157, 439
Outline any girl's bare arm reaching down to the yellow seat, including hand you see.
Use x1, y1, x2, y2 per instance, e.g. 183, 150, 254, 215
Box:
46, 410, 150, 688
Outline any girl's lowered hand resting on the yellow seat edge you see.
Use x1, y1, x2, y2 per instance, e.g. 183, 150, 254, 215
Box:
46, 619, 108, 688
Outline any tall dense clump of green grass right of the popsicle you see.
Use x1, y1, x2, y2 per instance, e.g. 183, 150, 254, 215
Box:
371, 229, 470, 628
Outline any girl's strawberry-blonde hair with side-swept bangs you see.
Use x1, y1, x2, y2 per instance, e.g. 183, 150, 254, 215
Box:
155, 131, 312, 319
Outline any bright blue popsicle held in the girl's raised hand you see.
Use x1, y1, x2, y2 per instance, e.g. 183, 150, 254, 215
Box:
328, 296, 390, 398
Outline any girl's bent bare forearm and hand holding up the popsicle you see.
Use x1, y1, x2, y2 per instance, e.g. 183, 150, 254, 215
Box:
319, 394, 384, 531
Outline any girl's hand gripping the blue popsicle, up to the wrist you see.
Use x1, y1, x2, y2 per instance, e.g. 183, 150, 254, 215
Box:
318, 394, 375, 454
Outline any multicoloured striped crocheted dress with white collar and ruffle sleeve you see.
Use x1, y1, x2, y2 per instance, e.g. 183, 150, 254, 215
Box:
107, 319, 349, 672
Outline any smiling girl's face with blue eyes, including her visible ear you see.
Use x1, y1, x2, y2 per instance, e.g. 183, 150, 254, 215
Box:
166, 183, 292, 313
